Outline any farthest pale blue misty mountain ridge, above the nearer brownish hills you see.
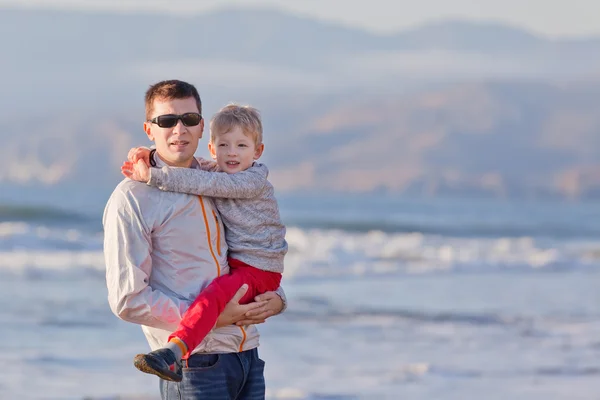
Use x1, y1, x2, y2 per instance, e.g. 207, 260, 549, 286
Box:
0, 8, 600, 102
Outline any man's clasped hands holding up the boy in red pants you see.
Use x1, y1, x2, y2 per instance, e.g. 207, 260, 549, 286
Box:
216, 285, 283, 328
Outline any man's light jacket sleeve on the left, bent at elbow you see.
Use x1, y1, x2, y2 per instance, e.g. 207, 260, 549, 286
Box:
103, 188, 189, 331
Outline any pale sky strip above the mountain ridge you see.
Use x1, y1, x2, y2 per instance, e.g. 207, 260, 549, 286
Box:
0, 0, 600, 37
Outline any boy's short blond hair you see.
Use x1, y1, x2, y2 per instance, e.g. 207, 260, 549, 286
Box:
210, 103, 262, 146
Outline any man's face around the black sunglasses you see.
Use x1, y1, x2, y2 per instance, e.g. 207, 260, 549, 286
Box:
144, 97, 204, 167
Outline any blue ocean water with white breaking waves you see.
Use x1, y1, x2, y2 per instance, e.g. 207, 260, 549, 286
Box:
0, 197, 600, 400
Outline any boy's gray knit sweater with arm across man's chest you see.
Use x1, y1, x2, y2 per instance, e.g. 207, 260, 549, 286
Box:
148, 158, 287, 273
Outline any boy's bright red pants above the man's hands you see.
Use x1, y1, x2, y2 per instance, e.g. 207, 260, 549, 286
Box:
169, 258, 281, 358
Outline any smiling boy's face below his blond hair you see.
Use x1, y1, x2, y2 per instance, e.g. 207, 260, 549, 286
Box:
208, 126, 265, 174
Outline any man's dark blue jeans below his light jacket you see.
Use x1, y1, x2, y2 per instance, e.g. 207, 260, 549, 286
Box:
160, 349, 265, 400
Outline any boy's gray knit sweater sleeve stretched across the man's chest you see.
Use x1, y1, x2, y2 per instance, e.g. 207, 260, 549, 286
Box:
148, 166, 268, 199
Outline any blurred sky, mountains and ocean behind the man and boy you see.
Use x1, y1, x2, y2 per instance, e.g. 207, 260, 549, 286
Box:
0, 0, 600, 400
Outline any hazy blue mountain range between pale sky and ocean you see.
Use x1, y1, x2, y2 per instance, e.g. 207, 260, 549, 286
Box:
0, 8, 600, 203
